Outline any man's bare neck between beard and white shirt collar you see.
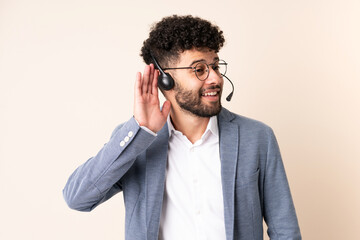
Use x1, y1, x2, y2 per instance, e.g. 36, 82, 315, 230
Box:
170, 108, 210, 143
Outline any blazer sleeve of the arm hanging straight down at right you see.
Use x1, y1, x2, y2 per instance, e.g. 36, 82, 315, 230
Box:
264, 129, 301, 240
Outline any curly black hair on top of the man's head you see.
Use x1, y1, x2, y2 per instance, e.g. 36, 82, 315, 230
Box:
140, 15, 225, 68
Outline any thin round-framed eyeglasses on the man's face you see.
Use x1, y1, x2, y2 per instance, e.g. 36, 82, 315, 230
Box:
163, 60, 227, 81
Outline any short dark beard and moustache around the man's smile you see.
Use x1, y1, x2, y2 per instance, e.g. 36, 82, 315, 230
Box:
174, 82, 222, 117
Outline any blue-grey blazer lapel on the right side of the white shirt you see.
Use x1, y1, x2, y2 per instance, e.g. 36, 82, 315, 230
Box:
218, 108, 239, 240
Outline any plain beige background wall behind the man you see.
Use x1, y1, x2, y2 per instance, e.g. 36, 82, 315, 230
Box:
0, 0, 360, 240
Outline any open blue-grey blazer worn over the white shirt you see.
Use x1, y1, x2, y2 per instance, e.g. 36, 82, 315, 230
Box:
63, 108, 301, 240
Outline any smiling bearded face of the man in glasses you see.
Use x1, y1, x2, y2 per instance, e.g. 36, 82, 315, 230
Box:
171, 50, 223, 117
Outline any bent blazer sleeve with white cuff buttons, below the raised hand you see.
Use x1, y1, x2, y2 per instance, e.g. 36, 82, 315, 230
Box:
63, 117, 156, 211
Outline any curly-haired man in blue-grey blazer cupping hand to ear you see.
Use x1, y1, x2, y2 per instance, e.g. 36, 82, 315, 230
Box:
64, 15, 301, 240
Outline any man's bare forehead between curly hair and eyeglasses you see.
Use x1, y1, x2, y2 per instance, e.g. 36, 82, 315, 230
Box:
178, 49, 219, 66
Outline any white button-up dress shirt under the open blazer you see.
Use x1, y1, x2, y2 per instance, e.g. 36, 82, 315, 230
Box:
159, 116, 226, 240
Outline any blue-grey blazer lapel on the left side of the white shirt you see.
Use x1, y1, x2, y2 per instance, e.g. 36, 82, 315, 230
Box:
145, 124, 169, 240
